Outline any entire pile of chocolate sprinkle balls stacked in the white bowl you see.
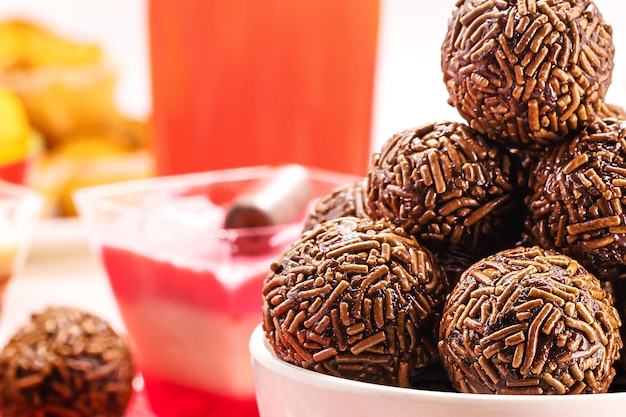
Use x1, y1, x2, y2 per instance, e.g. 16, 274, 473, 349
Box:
263, 0, 626, 394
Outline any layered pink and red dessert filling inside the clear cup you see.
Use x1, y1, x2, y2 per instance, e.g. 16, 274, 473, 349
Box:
102, 203, 301, 416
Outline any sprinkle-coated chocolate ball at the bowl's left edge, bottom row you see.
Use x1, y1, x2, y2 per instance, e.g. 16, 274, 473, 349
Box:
262, 217, 448, 387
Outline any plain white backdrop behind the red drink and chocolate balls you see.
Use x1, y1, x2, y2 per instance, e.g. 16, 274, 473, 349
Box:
0, 0, 626, 154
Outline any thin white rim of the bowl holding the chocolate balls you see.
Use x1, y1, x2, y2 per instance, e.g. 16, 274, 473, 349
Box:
249, 323, 626, 411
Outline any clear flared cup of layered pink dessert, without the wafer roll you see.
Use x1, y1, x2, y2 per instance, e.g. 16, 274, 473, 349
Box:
75, 167, 355, 417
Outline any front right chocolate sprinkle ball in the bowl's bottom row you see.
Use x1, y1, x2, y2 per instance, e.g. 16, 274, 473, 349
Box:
438, 246, 622, 394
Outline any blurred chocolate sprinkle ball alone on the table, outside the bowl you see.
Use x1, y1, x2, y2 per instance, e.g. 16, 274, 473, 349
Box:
0, 307, 134, 417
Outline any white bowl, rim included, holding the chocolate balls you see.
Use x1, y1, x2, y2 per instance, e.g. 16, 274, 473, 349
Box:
250, 325, 626, 417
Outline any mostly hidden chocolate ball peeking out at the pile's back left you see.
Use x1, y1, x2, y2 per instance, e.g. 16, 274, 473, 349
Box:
304, 178, 368, 230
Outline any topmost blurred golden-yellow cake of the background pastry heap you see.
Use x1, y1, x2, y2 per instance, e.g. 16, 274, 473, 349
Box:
0, 19, 117, 147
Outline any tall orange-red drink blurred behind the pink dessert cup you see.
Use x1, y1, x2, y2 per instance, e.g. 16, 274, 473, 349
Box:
149, 0, 379, 175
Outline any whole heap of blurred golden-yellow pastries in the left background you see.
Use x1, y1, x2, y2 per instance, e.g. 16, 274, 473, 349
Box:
0, 18, 153, 216
